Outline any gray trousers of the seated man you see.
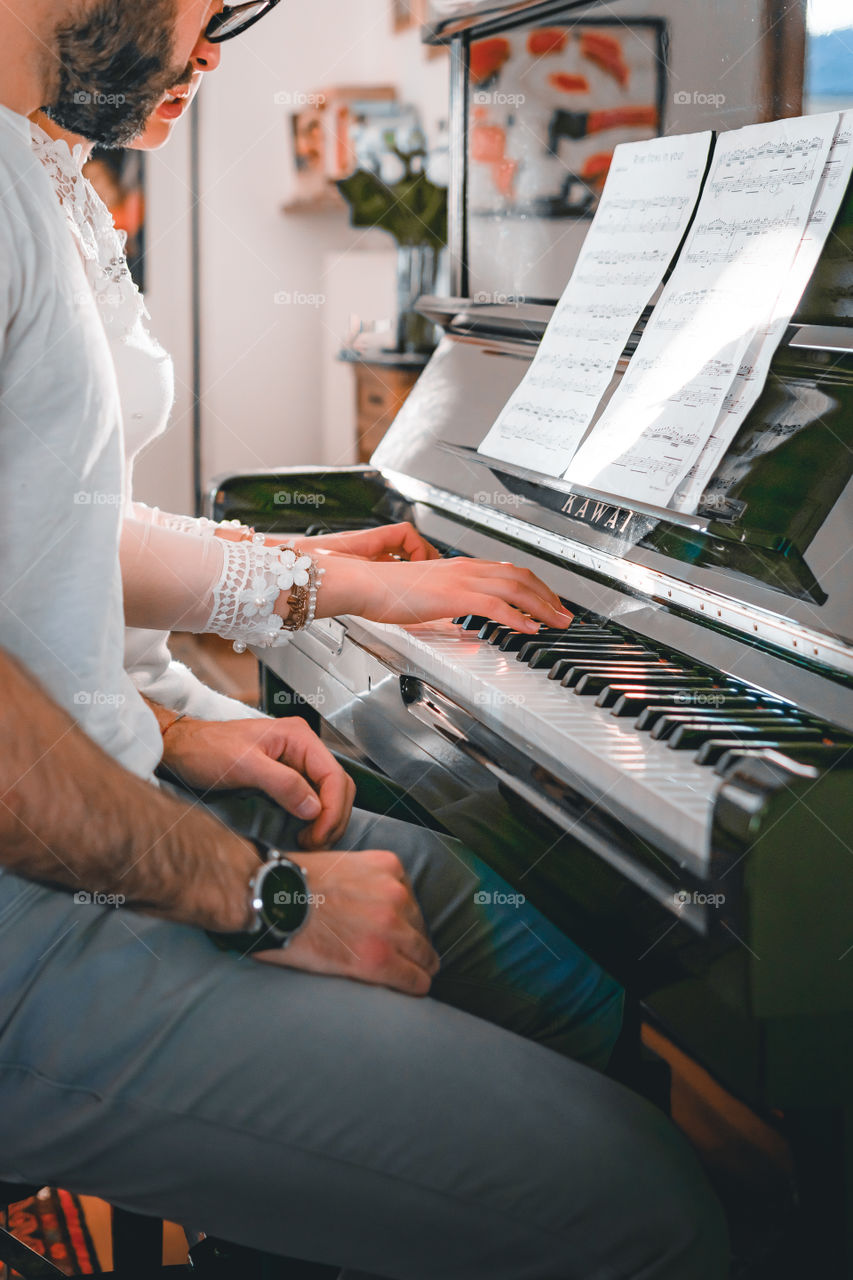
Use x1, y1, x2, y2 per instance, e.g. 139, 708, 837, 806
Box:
0, 796, 726, 1280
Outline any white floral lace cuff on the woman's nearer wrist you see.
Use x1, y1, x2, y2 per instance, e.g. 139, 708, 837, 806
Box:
205, 534, 325, 653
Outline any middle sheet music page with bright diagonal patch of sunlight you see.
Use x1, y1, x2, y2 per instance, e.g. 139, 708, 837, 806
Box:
566, 114, 839, 506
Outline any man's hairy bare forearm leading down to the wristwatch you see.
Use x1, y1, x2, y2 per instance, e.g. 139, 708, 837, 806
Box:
0, 650, 259, 932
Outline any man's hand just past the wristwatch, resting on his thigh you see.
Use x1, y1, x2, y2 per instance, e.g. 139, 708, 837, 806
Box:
256, 850, 439, 996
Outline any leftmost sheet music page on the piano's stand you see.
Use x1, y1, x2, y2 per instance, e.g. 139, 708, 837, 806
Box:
479, 133, 711, 476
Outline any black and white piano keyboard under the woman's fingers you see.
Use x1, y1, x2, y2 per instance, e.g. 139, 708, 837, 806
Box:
347, 605, 853, 870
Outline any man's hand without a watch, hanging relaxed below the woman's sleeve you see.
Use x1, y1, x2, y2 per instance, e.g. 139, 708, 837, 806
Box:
158, 721, 355, 849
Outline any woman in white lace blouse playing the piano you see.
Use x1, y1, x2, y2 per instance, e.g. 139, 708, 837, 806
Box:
32, 72, 571, 718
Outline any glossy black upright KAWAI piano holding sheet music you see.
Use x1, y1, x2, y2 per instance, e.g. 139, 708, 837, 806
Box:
210, 0, 853, 1276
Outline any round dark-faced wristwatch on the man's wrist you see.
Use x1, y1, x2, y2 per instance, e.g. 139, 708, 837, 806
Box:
211, 840, 311, 955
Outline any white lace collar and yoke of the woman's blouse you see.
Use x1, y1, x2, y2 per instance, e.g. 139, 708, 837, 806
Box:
29, 122, 147, 337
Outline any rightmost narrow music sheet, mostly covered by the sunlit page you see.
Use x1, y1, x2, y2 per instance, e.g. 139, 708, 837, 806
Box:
672, 110, 853, 511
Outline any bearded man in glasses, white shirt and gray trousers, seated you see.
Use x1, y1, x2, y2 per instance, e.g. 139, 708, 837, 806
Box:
0, 0, 725, 1280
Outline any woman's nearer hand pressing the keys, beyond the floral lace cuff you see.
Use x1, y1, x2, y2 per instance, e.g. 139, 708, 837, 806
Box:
318, 556, 573, 635
